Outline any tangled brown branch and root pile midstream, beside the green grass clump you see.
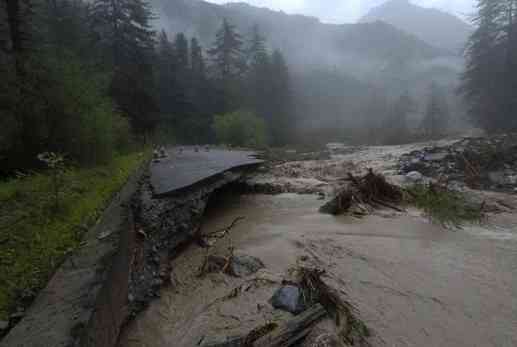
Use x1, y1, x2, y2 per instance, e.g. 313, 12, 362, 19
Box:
320, 169, 403, 215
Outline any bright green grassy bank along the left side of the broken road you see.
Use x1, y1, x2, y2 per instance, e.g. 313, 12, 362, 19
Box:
0, 153, 146, 320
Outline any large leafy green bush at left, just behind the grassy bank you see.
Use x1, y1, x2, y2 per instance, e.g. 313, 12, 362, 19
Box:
45, 52, 130, 165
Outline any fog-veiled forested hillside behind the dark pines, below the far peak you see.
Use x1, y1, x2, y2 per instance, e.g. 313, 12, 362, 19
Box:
153, 0, 464, 143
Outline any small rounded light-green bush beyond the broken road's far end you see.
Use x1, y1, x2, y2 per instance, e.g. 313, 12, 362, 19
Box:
214, 111, 267, 148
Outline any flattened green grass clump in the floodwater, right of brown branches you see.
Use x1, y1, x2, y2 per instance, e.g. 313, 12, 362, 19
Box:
406, 185, 483, 228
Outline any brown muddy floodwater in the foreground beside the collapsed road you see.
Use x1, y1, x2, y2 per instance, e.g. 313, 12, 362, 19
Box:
121, 194, 517, 347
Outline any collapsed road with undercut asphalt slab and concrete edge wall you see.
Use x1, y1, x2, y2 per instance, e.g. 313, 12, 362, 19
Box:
0, 148, 261, 347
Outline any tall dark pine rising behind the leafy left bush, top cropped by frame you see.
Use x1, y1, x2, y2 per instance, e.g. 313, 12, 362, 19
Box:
91, 0, 158, 139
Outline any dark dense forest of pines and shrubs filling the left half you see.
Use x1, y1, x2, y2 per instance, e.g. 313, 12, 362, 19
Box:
0, 0, 292, 173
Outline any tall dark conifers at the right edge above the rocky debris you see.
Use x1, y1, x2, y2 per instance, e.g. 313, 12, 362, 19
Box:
460, 0, 517, 131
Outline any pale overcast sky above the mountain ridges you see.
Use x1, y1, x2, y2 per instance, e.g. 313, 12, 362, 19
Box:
208, 0, 475, 23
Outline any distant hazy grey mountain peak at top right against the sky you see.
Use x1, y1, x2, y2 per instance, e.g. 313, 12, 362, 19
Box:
359, 0, 473, 54
